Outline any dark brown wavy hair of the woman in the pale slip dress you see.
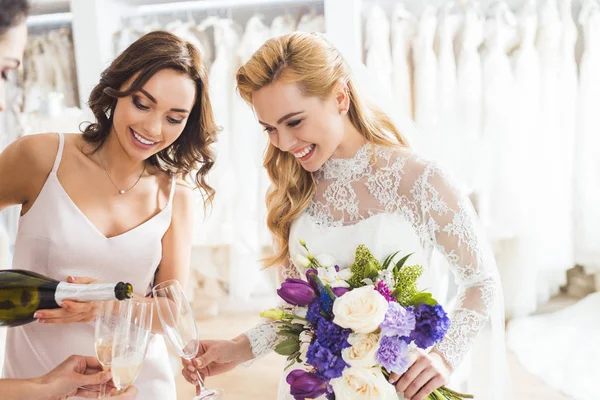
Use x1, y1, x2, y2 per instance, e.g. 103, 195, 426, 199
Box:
83, 31, 218, 205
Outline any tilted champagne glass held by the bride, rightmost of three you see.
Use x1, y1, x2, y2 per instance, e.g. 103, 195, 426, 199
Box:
152, 280, 223, 400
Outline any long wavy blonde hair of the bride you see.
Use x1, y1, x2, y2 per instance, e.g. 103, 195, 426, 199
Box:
236, 32, 408, 267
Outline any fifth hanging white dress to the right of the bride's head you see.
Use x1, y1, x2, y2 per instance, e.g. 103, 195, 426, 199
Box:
455, 3, 486, 197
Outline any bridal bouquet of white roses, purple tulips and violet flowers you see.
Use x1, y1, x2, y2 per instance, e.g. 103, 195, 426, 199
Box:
261, 240, 472, 400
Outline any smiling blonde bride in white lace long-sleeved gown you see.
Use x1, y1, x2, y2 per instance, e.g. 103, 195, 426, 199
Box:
183, 33, 508, 400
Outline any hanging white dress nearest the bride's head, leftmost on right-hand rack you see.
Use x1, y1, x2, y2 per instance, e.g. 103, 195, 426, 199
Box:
364, 4, 393, 104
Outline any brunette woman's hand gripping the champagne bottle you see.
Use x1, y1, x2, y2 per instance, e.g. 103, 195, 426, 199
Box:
33, 277, 98, 324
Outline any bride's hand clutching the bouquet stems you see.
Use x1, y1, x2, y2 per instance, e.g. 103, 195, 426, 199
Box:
390, 350, 451, 400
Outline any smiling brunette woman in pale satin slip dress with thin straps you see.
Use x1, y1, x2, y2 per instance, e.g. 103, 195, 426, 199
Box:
0, 29, 217, 400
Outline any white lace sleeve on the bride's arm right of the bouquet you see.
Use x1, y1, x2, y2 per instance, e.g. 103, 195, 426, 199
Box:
417, 164, 500, 369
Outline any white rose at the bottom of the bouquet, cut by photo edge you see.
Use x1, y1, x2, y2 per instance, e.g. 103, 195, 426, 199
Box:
330, 367, 398, 400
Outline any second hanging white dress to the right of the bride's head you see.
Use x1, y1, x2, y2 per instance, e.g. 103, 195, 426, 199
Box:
392, 3, 417, 119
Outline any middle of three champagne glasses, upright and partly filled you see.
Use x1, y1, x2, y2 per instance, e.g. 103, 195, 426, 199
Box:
111, 299, 153, 390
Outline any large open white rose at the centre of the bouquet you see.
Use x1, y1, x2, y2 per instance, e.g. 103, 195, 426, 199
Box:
333, 286, 388, 333
